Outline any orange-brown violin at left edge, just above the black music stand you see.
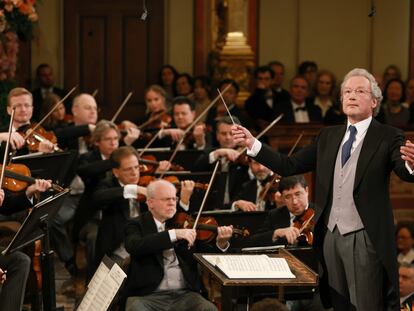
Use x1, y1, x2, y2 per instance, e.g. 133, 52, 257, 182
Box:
0, 164, 63, 192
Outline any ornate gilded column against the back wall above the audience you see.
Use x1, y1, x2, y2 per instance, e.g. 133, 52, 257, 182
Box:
209, 0, 255, 104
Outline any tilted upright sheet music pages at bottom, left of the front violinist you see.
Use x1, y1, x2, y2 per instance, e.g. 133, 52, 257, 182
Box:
77, 262, 126, 311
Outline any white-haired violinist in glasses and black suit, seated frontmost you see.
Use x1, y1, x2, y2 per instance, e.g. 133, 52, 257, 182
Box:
124, 180, 232, 311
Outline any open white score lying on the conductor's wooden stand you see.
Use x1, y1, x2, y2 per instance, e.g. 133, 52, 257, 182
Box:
203, 255, 295, 279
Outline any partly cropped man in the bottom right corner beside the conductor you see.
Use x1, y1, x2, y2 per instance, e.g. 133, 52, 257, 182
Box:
398, 263, 414, 311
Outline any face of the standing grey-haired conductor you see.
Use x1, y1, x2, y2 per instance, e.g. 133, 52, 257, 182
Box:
342, 76, 377, 124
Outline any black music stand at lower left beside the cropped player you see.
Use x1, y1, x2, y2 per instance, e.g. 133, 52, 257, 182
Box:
2, 189, 69, 311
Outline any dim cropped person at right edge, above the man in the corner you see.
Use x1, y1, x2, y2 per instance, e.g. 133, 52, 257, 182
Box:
396, 222, 414, 264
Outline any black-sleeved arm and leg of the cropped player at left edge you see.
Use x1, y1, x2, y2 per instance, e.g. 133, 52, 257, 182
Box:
0, 179, 51, 311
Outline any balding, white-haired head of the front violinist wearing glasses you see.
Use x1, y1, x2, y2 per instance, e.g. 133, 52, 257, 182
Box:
147, 183, 177, 223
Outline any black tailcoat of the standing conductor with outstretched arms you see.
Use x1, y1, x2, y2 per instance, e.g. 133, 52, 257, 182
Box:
252, 119, 414, 310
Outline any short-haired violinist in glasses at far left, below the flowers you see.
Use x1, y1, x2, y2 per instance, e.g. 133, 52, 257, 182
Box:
0, 87, 55, 155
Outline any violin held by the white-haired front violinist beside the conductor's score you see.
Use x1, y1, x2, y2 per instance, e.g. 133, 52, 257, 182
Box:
174, 212, 250, 243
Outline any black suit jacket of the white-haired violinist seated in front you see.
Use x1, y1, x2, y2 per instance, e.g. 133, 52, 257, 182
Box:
124, 212, 215, 298
